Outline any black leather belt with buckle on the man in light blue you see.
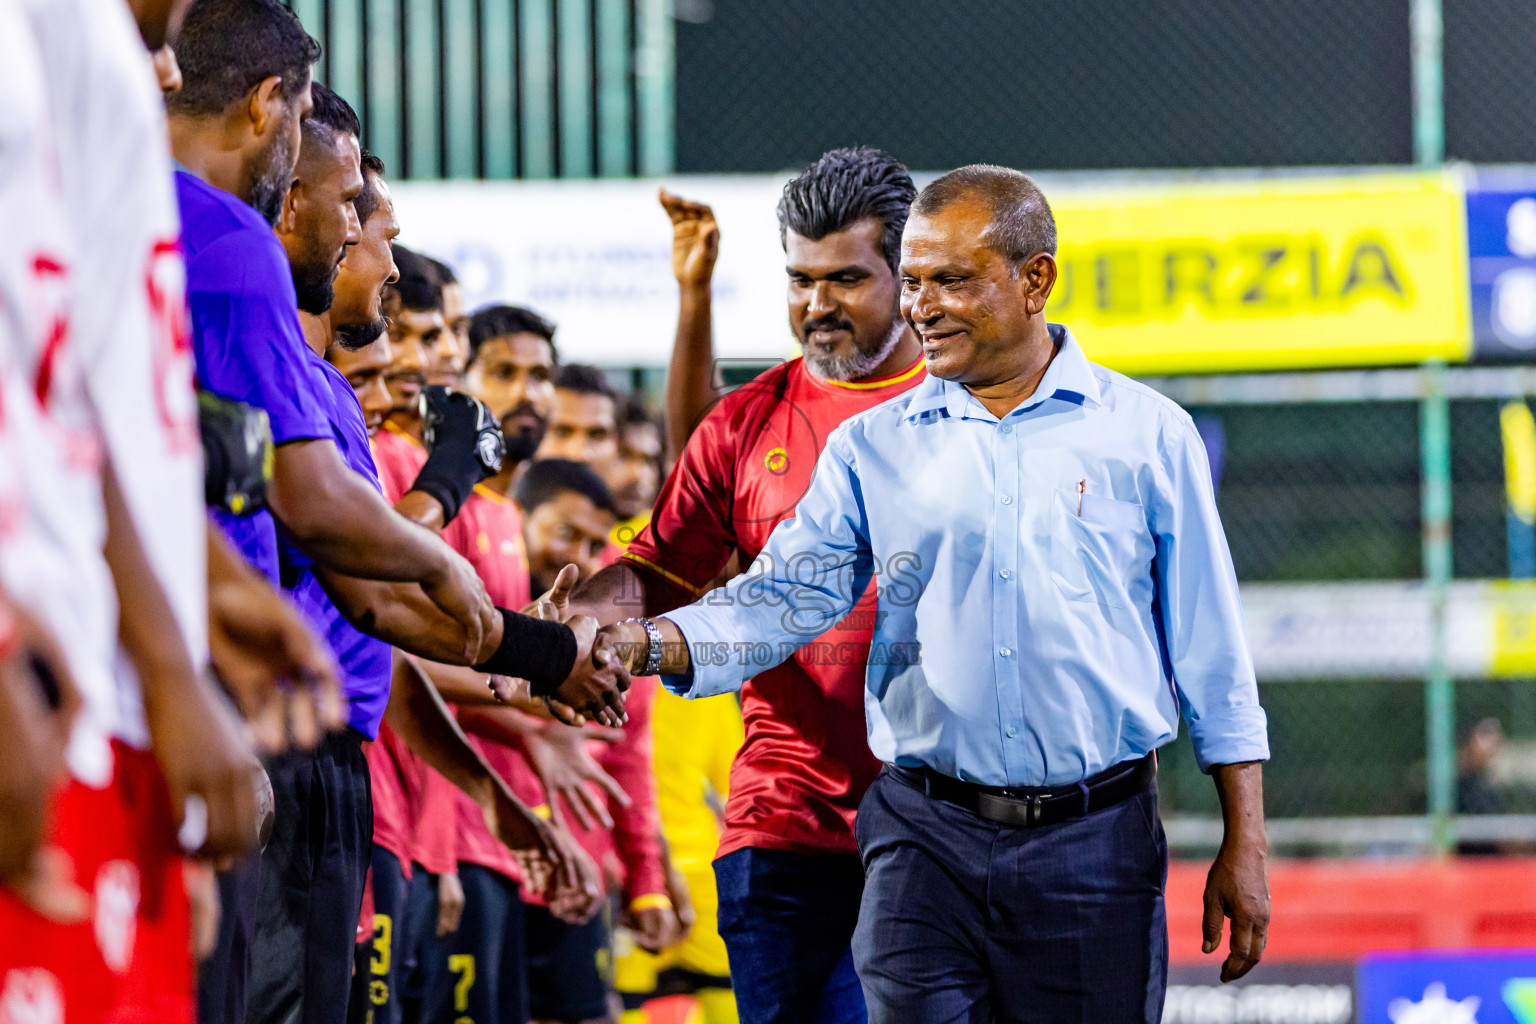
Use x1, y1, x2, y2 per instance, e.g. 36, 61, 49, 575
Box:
888, 751, 1157, 829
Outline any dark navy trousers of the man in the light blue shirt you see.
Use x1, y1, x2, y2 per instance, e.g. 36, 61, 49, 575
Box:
854, 769, 1167, 1024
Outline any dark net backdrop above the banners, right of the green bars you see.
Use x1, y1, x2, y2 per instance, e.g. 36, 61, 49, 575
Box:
676, 0, 1413, 172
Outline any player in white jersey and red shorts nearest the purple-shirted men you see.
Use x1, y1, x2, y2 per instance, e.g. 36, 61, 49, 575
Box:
9, 0, 271, 1022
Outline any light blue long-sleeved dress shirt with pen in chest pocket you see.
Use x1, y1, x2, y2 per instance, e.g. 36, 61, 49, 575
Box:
664, 324, 1269, 786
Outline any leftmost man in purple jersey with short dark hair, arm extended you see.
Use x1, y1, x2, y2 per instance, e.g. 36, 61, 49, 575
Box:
167, 0, 496, 657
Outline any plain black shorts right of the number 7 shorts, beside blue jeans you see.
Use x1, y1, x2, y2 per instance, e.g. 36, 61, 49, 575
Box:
527, 904, 613, 1024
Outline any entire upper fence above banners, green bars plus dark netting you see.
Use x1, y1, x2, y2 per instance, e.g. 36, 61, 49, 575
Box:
289, 0, 1536, 178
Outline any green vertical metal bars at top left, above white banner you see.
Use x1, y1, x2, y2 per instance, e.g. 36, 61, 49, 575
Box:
292, 0, 673, 178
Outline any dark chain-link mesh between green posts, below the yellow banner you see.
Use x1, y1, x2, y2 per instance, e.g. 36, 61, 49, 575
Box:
1154, 370, 1536, 852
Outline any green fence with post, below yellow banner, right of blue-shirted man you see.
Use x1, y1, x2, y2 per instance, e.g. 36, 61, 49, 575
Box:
1149, 367, 1536, 852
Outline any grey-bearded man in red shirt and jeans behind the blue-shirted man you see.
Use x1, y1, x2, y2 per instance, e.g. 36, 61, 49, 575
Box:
571, 149, 923, 1024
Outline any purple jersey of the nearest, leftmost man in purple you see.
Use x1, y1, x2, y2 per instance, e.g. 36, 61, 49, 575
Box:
177, 170, 332, 583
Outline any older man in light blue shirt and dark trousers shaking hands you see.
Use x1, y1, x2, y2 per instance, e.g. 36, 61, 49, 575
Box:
611, 167, 1269, 1022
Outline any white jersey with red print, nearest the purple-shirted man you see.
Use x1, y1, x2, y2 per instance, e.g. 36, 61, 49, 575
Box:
31, 0, 207, 761
